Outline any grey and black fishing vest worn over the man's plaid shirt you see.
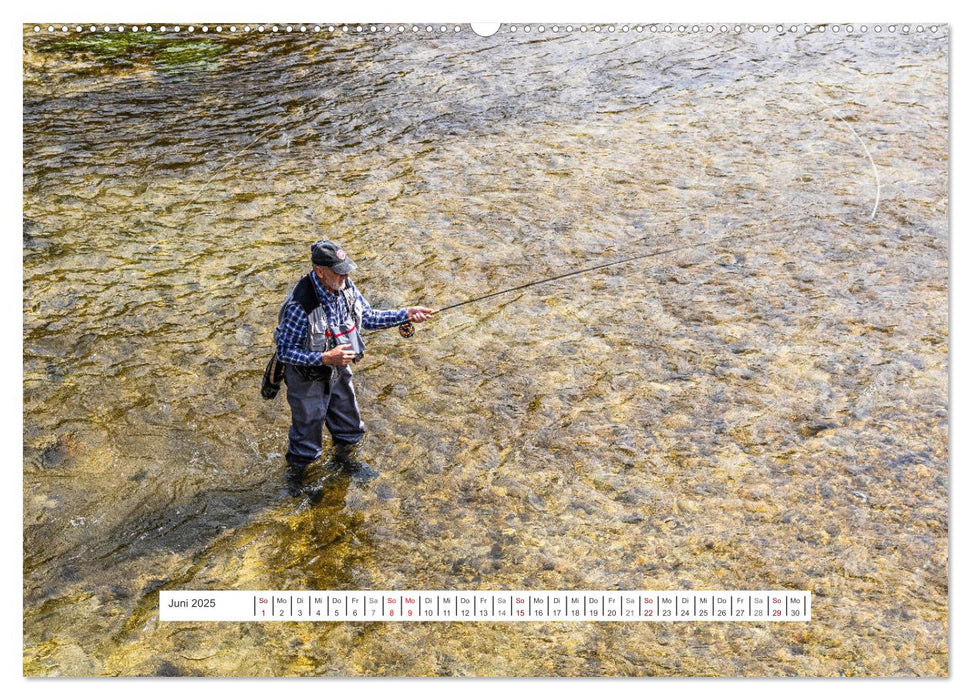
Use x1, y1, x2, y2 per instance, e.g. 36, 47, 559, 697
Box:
278, 272, 364, 380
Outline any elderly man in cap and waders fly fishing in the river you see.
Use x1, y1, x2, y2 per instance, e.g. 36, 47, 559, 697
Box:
262, 240, 436, 499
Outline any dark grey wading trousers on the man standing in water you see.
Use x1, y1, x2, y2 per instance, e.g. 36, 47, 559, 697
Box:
283, 365, 364, 466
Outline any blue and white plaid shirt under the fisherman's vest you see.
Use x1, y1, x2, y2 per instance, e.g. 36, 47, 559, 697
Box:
273, 273, 408, 365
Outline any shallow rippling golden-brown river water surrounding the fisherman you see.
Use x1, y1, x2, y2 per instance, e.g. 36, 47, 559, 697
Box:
23, 25, 949, 676
